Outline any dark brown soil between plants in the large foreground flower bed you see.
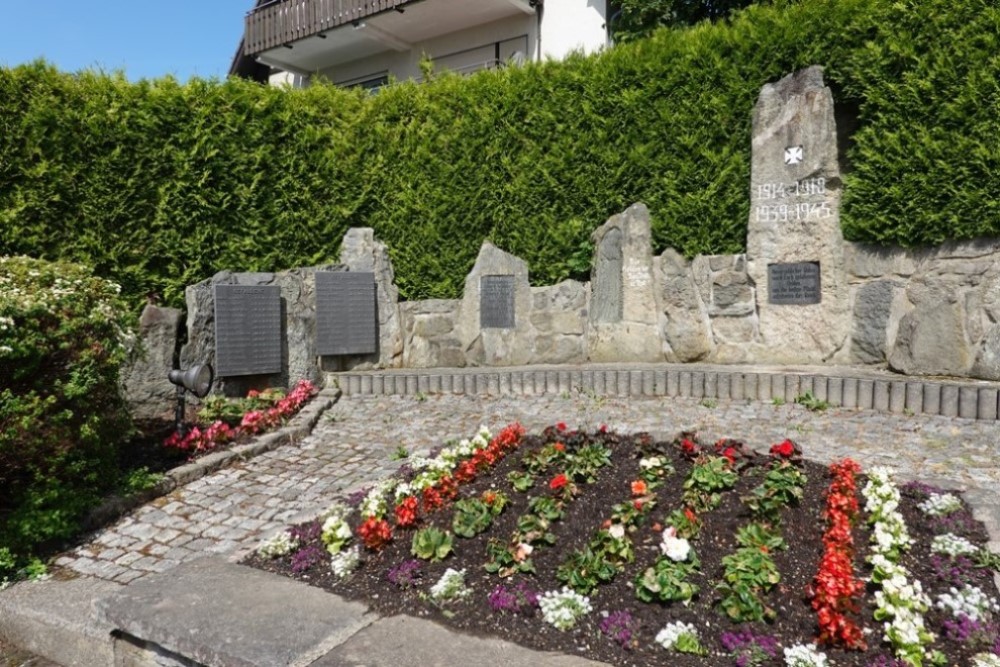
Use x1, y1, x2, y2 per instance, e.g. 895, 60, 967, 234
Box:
246, 429, 997, 667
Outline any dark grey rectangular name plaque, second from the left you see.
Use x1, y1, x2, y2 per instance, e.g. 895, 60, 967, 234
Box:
316, 271, 378, 356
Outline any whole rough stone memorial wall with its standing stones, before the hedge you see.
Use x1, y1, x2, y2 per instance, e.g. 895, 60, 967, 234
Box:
126, 67, 1000, 412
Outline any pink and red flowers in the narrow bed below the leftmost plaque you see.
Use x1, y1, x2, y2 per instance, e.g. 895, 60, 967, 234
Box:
163, 380, 317, 452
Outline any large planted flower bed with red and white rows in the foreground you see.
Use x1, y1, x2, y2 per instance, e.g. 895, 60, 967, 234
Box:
248, 424, 1000, 667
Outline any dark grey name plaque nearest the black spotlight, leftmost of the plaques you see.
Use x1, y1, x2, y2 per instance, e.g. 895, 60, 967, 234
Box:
213, 285, 281, 377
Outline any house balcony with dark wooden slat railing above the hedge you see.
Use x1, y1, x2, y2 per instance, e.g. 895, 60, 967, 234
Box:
243, 0, 535, 74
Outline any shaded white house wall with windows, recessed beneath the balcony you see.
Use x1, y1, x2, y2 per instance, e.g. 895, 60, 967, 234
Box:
319, 14, 551, 84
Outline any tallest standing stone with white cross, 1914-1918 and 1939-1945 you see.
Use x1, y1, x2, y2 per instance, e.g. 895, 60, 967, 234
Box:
747, 67, 850, 363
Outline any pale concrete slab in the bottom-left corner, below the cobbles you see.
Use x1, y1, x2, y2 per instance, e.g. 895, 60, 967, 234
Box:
0, 577, 122, 667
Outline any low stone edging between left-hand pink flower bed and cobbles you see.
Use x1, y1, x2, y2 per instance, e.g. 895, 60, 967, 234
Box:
83, 388, 342, 530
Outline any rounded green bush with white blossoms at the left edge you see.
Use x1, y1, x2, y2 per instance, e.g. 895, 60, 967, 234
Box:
0, 257, 132, 579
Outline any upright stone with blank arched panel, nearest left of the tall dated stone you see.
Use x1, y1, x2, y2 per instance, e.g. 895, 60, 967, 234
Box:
588, 204, 664, 362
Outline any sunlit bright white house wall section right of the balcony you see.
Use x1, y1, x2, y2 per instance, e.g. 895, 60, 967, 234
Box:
541, 0, 608, 60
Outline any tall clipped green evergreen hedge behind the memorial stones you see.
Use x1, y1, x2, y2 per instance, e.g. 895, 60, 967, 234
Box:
0, 0, 1000, 305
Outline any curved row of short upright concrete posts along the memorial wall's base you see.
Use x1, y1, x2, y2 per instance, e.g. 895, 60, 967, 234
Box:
327, 364, 1000, 420
